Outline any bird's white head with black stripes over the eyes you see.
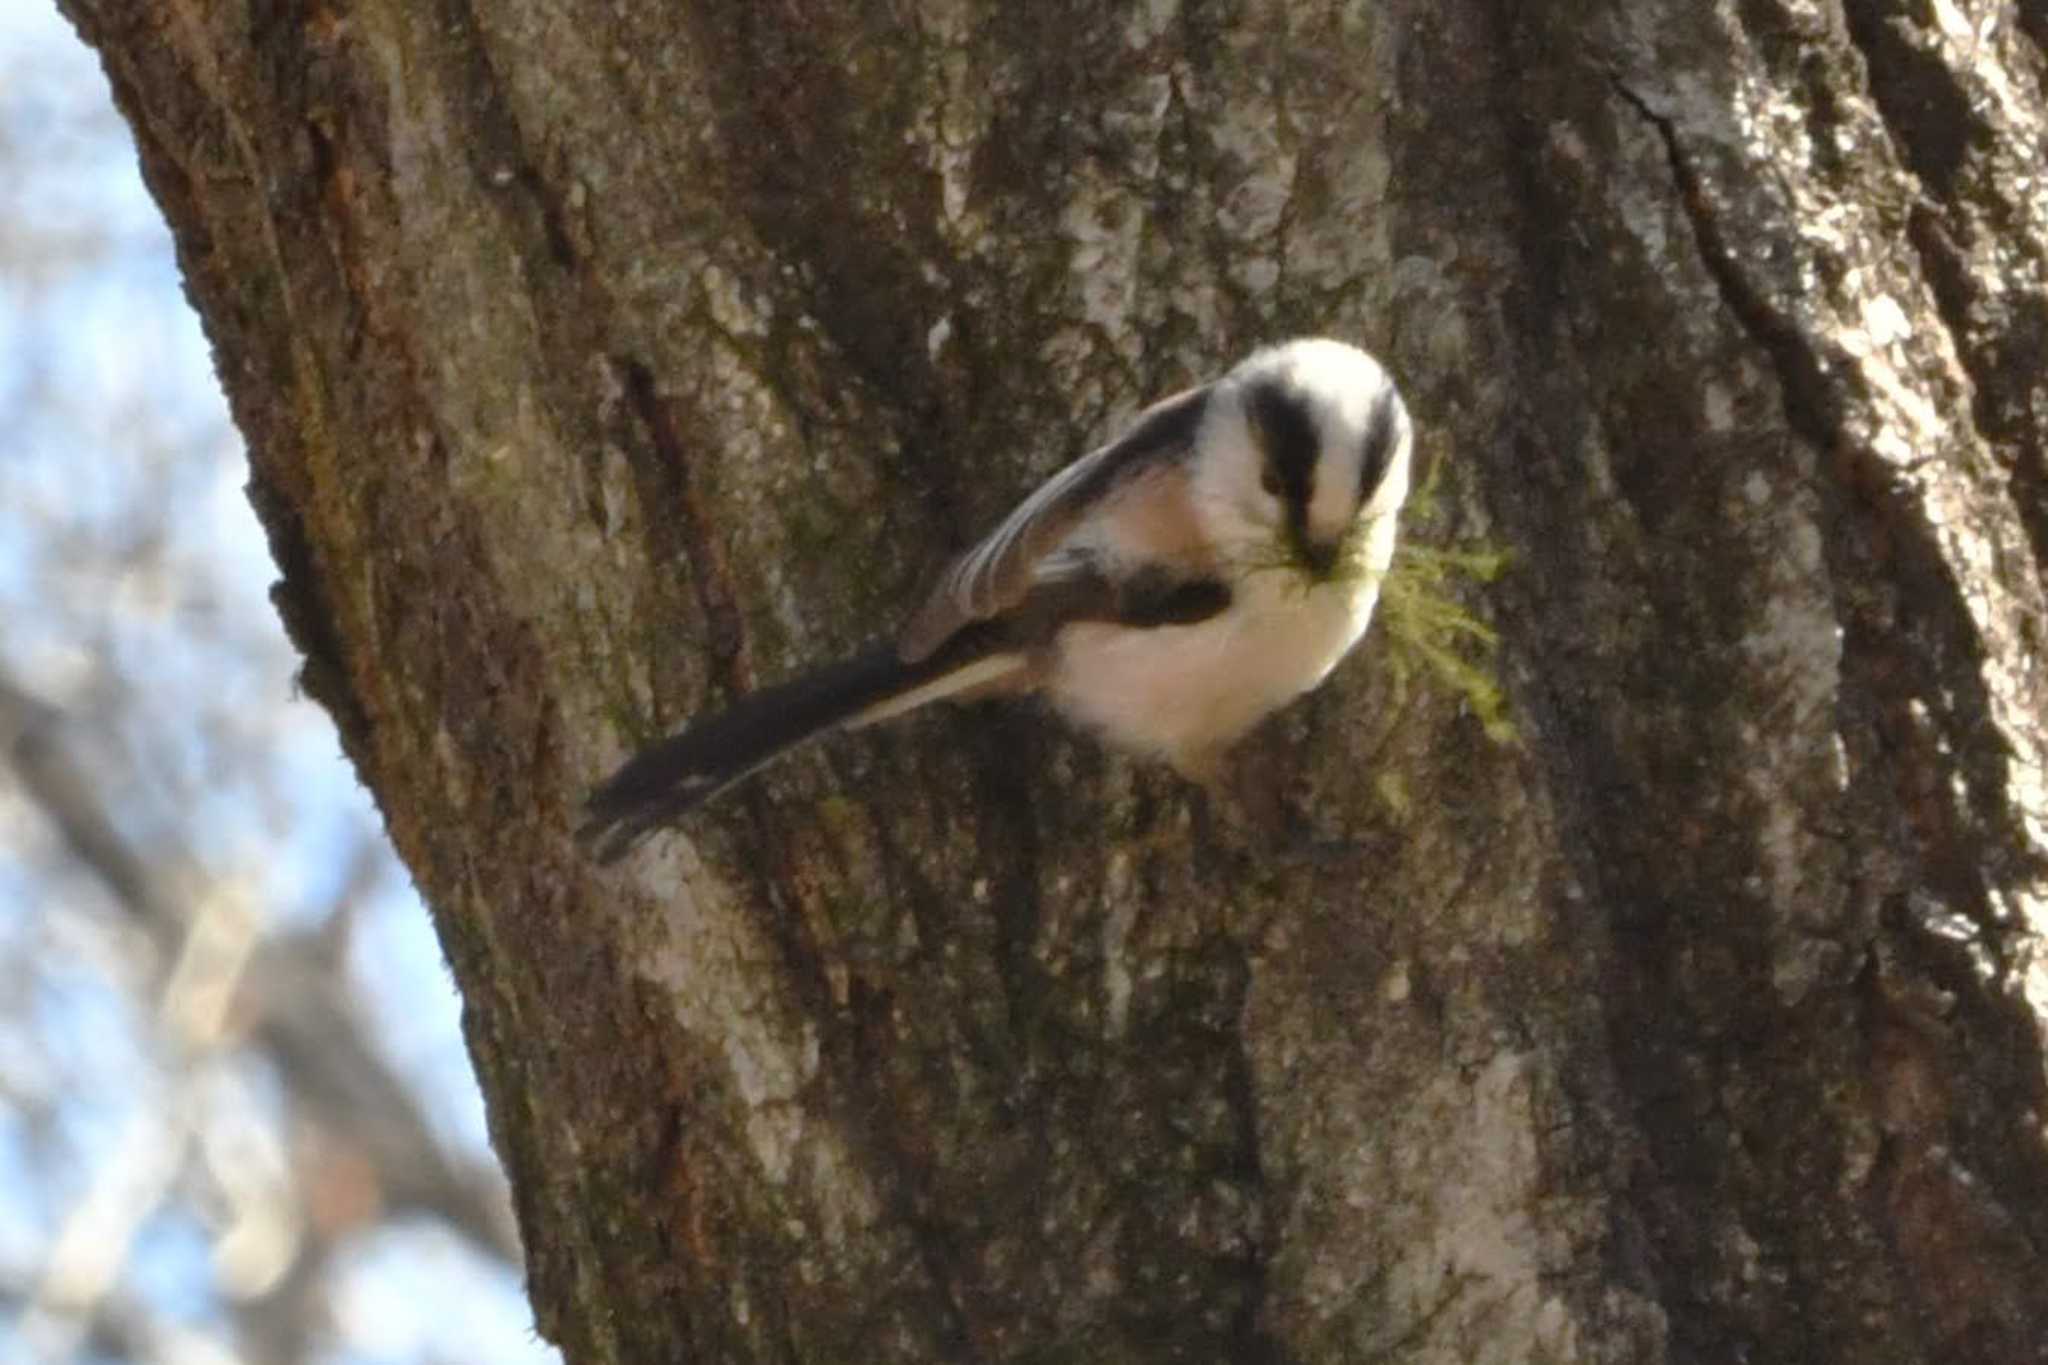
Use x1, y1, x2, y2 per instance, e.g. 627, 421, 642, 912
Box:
1196, 338, 1413, 579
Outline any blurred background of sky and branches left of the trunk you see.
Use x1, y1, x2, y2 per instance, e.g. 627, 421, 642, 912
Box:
0, 0, 553, 1365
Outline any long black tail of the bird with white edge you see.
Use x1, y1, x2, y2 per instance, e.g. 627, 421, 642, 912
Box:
575, 645, 1004, 862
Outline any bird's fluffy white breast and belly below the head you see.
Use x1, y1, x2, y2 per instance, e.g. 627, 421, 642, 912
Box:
1047, 540, 1393, 774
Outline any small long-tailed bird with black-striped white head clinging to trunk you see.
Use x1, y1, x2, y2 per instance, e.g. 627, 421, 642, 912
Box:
580, 340, 1413, 862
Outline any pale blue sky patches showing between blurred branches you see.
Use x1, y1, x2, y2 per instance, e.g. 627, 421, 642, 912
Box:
0, 0, 553, 1365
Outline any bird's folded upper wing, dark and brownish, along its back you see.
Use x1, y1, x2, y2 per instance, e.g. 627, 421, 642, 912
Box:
897, 385, 1208, 663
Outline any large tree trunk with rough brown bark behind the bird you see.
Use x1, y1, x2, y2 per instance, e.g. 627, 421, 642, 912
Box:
68, 0, 2048, 1365
